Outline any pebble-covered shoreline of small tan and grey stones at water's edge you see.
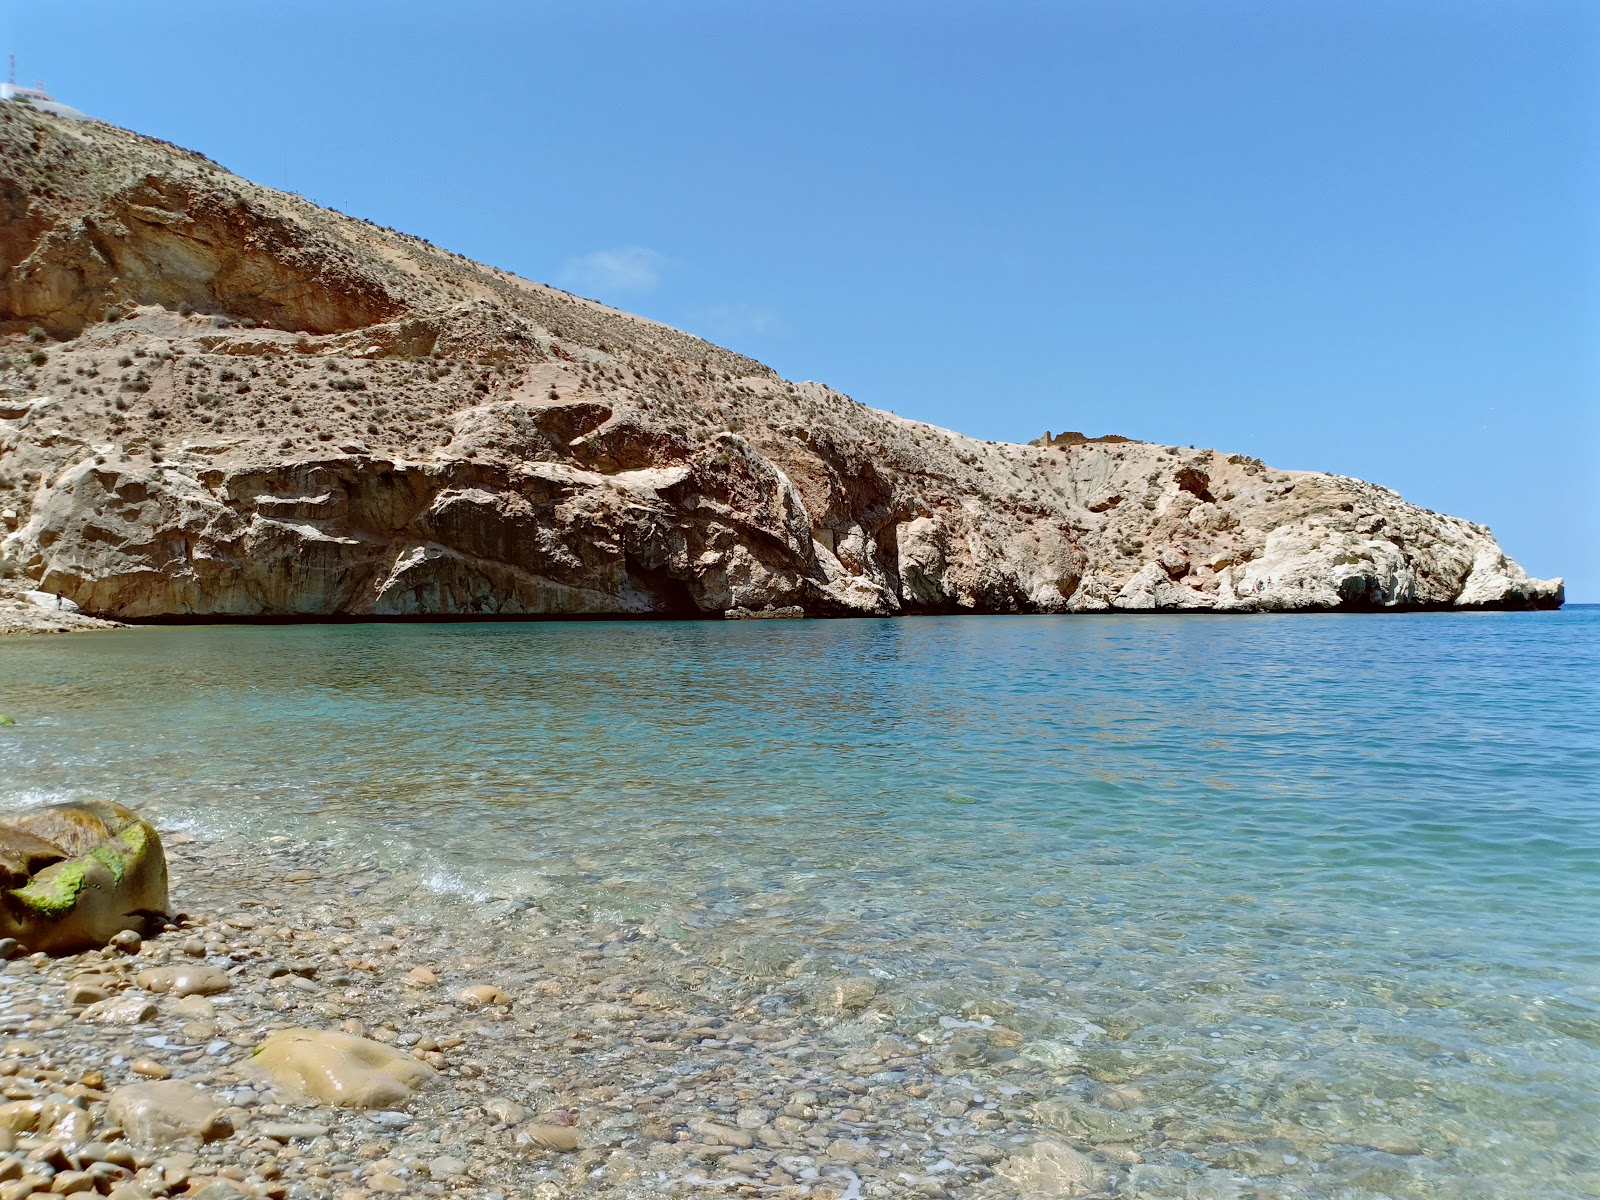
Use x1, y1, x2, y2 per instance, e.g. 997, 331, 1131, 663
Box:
0, 835, 1100, 1200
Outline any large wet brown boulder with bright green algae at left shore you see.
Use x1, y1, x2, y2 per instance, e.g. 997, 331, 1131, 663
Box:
0, 802, 166, 954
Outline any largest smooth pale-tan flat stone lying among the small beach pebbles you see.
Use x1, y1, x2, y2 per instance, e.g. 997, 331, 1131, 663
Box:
254, 1029, 434, 1109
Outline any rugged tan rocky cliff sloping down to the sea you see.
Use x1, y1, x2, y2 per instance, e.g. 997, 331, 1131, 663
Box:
0, 106, 1562, 619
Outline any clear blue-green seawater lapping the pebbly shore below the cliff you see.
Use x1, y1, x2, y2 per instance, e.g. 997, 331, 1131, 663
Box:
0, 608, 1600, 1197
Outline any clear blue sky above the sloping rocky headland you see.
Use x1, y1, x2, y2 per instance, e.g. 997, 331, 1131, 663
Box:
0, 0, 1600, 602
